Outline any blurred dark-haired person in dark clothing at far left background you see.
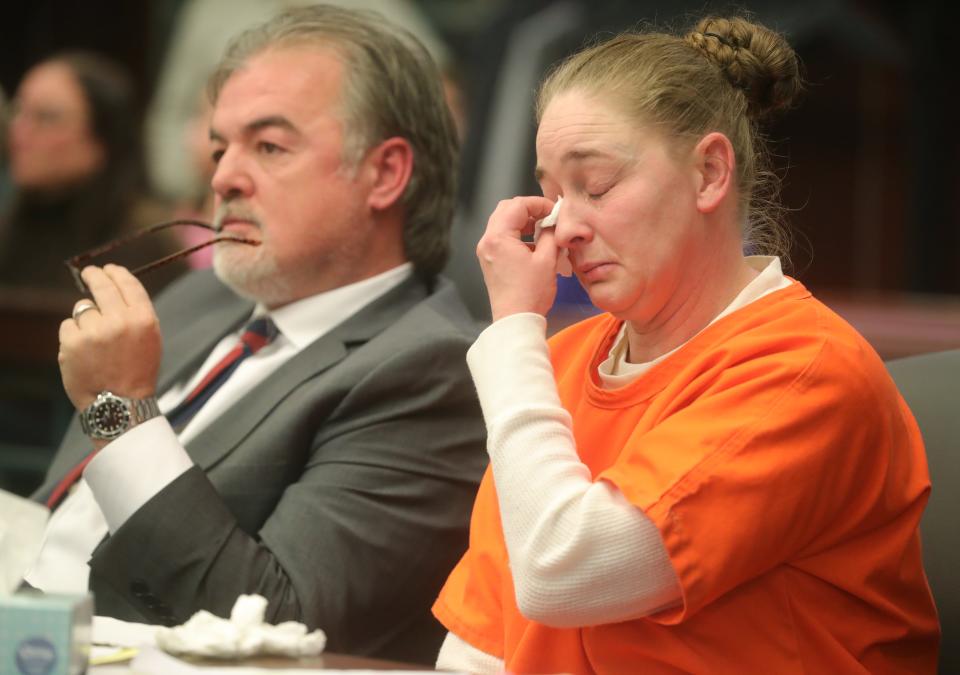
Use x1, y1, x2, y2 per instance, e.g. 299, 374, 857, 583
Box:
0, 52, 185, 486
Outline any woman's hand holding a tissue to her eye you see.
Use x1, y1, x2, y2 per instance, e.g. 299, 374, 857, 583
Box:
477, 197, 560, 321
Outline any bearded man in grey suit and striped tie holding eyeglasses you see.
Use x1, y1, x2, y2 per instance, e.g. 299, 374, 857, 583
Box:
26, 7, 485, 662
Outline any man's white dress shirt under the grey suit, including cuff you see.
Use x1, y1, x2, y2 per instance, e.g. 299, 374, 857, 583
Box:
24, 263, 412, 593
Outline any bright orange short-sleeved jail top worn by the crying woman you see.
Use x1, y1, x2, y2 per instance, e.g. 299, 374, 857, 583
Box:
434, 283, 939, 673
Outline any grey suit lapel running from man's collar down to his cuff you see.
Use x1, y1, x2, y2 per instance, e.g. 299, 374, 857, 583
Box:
186, 278, 427, 470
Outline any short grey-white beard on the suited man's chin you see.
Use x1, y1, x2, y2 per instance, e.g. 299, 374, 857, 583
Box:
213, 242, 291, 307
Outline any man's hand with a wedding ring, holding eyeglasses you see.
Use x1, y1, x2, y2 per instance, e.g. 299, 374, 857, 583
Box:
57, 265, 161, 410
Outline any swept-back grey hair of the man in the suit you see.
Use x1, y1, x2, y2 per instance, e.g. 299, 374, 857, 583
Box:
208, 5, 459, 279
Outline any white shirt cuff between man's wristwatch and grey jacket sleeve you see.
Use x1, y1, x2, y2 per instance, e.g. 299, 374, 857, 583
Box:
83, 416, 193, 534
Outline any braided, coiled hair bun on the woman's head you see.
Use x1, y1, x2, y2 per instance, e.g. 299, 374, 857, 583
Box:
686, 17, 803, 118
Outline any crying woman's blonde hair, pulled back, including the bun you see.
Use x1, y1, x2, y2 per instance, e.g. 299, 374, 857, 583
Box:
537, 17, 802, 256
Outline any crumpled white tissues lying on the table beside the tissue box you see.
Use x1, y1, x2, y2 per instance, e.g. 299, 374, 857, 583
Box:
157, 595, 327, 658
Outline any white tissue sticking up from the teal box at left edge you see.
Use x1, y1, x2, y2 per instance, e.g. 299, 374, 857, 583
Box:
0, 490, 50, 595
